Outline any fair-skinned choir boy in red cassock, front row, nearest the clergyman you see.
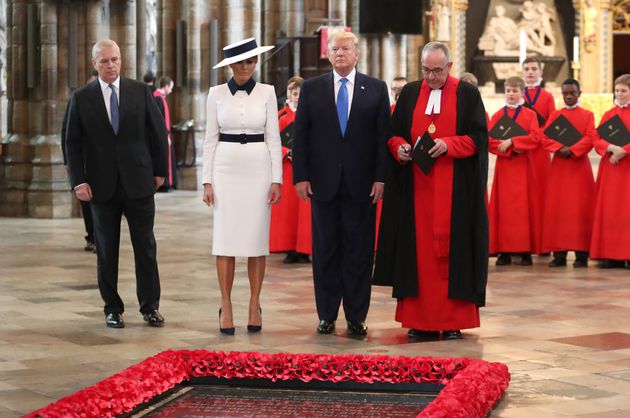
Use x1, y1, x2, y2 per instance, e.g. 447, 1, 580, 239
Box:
488, 77, 541, 266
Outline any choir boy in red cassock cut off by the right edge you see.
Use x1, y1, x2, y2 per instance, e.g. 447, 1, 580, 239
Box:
591, 74, 630, 268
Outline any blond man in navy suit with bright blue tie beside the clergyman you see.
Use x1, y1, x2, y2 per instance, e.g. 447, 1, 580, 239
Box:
292, 32, 389, 336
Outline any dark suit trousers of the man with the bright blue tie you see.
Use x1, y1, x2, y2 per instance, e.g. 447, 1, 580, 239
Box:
311, 179, 376, 321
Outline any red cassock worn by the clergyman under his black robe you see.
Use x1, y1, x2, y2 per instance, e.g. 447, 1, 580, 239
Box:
388, 77, 479, 331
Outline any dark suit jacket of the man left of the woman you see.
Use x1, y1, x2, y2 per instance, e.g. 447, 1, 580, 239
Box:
66, 77, 168, 202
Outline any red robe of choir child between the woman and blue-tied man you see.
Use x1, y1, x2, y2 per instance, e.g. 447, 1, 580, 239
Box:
269, 106, 312, 254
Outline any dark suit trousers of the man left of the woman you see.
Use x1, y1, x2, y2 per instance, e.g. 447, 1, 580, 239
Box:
90, 181, 160, 315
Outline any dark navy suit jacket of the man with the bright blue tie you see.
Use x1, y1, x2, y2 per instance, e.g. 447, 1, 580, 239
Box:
292, 72, 389, 201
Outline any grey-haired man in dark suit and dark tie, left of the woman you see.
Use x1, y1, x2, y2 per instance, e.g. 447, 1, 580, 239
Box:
66, 39, 168, 328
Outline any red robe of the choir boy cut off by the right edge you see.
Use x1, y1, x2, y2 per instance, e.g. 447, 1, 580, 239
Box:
590, 106, 630, 260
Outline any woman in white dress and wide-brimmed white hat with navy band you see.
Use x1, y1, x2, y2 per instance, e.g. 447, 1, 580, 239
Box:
203, 38, 282, 335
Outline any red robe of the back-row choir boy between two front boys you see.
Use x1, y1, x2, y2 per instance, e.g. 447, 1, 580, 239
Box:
523, 86, 556, 212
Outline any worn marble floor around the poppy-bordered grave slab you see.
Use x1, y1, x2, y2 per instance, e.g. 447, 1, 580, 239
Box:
0, 191, 630, 418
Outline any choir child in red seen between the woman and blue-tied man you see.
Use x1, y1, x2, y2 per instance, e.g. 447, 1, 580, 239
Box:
269, 76, 311, 264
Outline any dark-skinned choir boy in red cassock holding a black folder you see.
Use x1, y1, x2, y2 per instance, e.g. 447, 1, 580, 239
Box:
514, 79, 596, 267
